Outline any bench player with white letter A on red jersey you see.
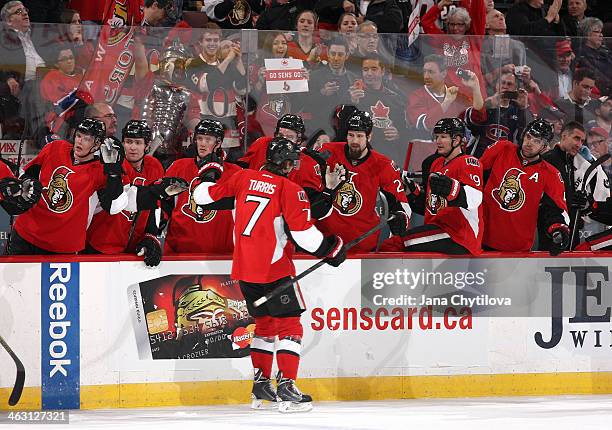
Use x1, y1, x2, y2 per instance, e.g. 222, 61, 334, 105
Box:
480, 119, 569, 255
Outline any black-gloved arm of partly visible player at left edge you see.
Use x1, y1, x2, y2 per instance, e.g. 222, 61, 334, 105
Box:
0, 159, 42, 215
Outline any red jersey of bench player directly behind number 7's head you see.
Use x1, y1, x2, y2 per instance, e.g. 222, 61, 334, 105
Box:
240, 136, 323, 191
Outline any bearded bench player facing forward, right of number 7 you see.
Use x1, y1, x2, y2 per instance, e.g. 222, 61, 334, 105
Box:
312, 111, 411, 252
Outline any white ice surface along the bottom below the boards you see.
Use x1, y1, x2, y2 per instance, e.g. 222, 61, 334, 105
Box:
5, 395, 612, 430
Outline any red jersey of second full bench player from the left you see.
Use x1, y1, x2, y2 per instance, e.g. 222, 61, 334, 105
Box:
87, 155, 164, 254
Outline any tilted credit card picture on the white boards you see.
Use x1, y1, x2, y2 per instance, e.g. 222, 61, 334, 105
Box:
127, 275, 255, 360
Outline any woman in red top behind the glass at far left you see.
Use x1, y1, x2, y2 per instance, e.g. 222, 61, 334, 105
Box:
40, 43, 82, 105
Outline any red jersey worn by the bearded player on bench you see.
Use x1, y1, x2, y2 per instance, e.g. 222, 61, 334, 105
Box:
317, 142, 410, 252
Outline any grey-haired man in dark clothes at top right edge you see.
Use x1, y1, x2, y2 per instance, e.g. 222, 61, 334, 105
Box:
576, 18, 612, 94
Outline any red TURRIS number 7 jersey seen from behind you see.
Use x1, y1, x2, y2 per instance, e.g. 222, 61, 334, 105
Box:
195, 169, 323, 283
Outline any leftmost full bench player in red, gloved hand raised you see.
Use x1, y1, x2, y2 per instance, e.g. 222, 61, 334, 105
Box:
8, 118, 127, 255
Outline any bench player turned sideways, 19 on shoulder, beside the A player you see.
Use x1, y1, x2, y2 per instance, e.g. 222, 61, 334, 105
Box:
404, 118, 483, 255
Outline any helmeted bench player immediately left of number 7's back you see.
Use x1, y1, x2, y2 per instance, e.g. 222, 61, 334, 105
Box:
164, 119, 241, 255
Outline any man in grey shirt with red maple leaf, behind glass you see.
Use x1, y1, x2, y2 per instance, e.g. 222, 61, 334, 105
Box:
348, 55, 407, 163
